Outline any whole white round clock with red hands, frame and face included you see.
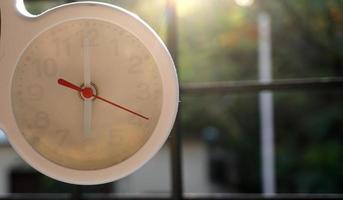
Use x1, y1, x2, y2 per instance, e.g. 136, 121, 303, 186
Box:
0, 0, 179, 185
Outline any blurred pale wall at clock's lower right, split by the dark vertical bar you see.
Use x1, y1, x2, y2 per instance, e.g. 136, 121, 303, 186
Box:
116, 141, 220, 193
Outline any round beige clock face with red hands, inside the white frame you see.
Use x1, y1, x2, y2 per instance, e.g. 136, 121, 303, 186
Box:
12, 19, 163, 170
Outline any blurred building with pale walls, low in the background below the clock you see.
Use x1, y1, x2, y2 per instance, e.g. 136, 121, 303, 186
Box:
0, 134, 225, 196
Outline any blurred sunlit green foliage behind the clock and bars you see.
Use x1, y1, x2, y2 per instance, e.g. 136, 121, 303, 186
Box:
24, 0, 343, 193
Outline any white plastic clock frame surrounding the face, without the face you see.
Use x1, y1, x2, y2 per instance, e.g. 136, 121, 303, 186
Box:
0, 0, 179, 185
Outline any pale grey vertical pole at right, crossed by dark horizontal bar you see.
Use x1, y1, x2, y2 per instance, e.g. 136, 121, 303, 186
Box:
258, 12, 275, 196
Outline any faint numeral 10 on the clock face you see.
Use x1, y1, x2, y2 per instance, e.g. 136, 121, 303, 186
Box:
33, 58, 58, 78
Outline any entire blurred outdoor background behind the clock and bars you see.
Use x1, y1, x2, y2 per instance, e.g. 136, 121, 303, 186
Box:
0, 0, 343, 195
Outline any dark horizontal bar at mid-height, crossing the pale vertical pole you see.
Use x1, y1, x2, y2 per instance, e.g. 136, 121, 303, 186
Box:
181, 77, 343, 94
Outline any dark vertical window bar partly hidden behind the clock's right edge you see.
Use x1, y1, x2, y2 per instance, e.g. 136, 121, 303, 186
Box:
166, 0, 183, 200
